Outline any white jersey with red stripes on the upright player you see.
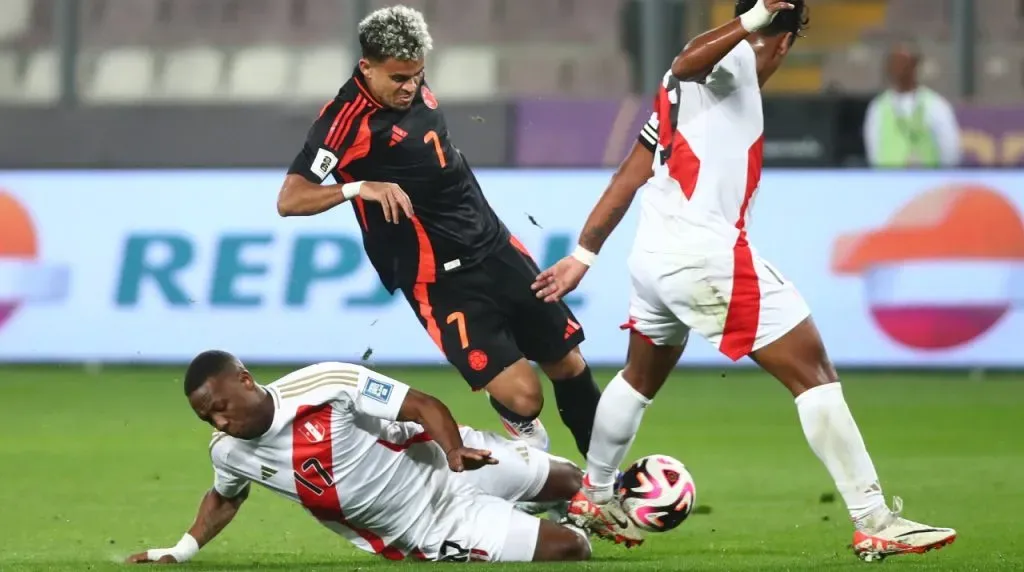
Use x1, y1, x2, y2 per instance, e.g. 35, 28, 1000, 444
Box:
637, 41, 764, 252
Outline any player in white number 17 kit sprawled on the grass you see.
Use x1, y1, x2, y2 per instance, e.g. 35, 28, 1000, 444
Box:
128, 351, 590, 563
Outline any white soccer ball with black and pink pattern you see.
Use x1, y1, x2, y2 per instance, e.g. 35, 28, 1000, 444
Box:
618, 454, 696, 532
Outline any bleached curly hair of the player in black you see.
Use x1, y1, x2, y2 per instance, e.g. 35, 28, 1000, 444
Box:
359, 4, 434, 61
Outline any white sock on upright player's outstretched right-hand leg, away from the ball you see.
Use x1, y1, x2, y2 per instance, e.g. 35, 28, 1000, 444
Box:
797, 383, 886, 522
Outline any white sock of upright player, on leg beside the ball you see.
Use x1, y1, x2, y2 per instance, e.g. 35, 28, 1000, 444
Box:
587, 371, 650, 502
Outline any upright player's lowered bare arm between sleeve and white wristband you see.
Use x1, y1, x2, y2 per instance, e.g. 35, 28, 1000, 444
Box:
580, 142, 654, 253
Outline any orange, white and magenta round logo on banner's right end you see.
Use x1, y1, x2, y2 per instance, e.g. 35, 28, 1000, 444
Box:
831, 183, 1024, 350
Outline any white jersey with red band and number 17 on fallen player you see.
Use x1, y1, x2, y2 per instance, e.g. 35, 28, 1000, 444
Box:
210, 362, 479, 560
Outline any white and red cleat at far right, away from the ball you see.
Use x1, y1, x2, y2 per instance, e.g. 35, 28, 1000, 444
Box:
853, 496, 956, 562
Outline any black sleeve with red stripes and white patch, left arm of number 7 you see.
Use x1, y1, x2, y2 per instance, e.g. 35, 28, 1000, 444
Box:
288, 96, 372, 184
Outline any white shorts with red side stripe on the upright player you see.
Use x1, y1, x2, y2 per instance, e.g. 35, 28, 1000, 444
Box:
623, 242, 811, 361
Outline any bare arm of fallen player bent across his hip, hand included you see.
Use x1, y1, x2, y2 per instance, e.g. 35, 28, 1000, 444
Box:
398, 388, 498, 473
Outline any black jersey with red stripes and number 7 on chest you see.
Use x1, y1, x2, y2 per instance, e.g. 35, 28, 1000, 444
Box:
289, 68, 510, 293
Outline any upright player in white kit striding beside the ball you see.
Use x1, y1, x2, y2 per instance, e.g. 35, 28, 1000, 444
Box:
534, 0, 956, 560
